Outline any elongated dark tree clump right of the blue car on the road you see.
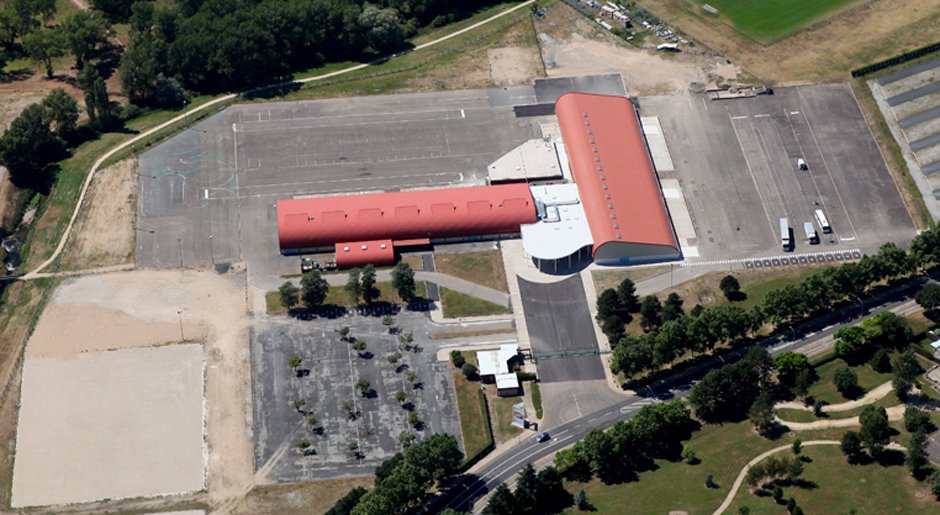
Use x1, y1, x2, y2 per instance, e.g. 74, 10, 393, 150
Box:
555, 400, 696, 483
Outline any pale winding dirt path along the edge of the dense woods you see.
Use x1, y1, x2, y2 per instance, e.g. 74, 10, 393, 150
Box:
19, 0, 535, 280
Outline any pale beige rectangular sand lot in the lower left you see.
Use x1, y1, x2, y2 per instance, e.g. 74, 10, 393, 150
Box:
12, 344, 205, 507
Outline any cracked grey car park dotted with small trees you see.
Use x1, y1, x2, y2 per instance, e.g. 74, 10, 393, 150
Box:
251, 313, 460, 482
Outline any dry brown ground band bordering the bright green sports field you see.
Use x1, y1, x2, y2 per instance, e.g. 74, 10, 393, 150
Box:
638, 0, 940, 84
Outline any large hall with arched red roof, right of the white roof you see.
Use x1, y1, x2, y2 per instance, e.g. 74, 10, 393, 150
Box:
555, 93, 679, 258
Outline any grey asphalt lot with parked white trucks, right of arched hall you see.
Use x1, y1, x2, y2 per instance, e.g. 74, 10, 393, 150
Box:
639, 84, 915, 260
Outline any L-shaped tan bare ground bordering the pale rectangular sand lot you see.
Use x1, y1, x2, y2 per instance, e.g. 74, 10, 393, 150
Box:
14, 267, 254, 510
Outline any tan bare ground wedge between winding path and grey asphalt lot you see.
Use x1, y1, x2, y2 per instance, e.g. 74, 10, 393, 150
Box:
62, 158, 138, 270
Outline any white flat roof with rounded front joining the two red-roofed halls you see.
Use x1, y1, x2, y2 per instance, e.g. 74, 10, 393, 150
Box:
521, 184, 594, 260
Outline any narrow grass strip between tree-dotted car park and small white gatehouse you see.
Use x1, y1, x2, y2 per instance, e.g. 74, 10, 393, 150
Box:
453, 352, 493, 463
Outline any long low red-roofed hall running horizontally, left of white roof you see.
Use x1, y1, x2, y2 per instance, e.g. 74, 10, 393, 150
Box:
277, 184, 536, 252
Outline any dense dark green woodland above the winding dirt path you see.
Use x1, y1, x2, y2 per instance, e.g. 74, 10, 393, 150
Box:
122, 0, 516, 105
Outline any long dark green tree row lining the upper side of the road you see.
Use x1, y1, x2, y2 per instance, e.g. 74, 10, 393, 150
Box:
597, 231, 940, 378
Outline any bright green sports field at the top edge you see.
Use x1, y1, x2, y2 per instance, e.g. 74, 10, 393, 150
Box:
700, 0, 857, 43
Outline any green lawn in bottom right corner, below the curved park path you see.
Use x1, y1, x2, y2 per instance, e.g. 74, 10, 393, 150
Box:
725, 445, 940, 514
